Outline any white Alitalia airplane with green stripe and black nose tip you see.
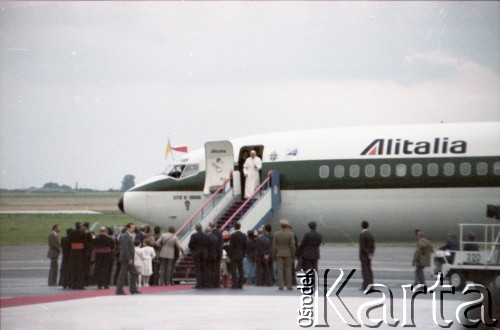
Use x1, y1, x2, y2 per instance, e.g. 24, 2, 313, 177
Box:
118, 122, 500, 243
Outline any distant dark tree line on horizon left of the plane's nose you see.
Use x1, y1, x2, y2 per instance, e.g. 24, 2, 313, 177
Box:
0, 174, 135, 194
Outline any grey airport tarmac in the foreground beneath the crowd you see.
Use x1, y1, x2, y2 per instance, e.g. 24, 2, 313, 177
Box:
0, 246, 500, 330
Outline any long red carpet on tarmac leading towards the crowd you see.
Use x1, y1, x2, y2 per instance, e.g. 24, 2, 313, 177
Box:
0, 284, 193, 308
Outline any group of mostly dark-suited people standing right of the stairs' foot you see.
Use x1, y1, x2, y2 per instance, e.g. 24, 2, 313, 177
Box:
189, 219, 322, 290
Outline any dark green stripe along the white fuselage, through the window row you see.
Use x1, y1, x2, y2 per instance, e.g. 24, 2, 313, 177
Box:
131, 157, 500, 191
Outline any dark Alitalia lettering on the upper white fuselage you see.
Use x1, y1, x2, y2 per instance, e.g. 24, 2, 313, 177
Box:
361, 137, 467, 156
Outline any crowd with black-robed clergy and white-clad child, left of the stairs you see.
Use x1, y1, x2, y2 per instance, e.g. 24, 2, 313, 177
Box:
47, 221, 168, 290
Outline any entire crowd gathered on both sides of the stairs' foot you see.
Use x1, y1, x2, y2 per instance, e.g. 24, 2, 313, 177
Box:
47, 220, 328, 294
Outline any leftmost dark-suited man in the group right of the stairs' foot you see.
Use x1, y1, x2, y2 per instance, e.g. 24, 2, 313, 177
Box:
188, 224, 208, 289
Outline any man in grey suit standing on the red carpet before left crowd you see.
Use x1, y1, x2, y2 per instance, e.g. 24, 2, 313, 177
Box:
116, 223, 141, 295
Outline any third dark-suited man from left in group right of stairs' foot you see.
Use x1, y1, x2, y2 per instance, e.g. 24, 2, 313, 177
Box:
229, 223, 247, 289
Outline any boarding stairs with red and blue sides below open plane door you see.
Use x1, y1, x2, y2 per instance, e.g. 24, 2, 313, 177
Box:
173, 171, 281, 282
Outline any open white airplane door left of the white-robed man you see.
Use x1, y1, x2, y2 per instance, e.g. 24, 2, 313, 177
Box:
203, 141, 234, 195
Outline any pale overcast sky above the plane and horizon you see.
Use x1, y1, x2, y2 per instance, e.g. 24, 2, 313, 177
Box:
0, 1, 500, 189
